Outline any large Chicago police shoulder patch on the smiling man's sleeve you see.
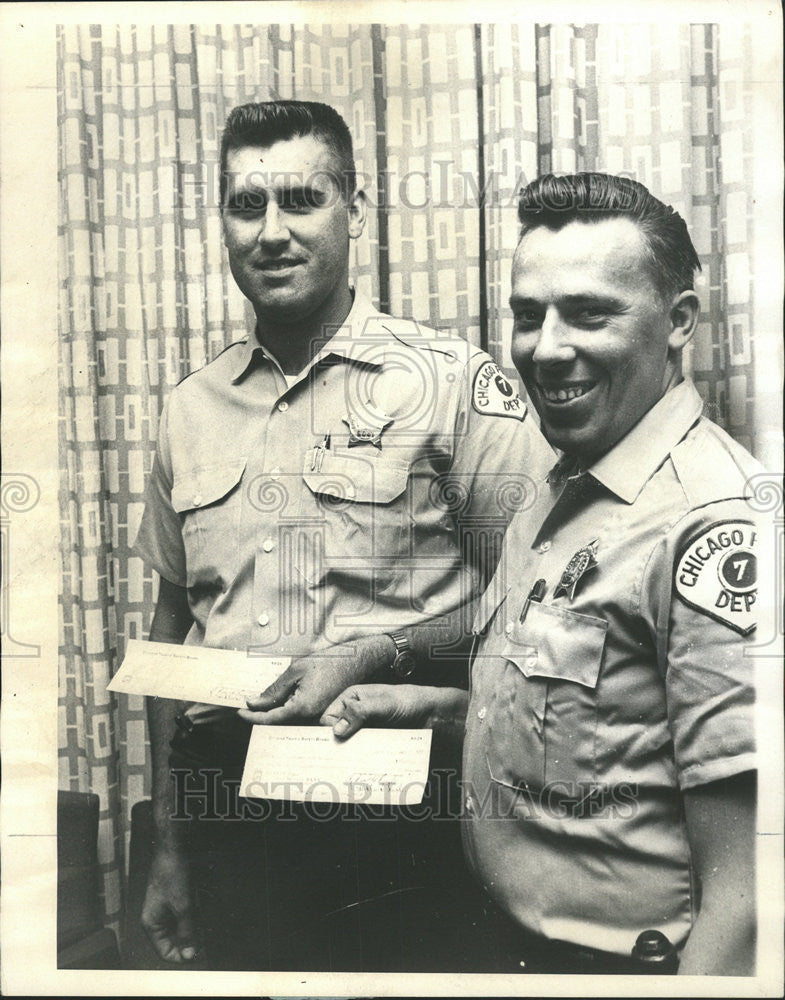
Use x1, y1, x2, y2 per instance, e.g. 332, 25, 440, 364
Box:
674, 521, 758, 635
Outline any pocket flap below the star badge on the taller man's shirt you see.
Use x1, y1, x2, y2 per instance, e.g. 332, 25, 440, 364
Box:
303, 449, 409, 503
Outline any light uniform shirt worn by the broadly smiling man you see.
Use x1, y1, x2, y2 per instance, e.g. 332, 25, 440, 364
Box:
464, 382, 760, 955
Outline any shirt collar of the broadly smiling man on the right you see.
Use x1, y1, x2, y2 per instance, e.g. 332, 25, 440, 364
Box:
549, 382, 703, 503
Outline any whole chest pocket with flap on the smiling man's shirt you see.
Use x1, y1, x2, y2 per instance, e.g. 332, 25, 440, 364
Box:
500, 602, 608, 798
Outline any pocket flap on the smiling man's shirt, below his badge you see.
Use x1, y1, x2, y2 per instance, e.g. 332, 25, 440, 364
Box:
502, 602, 608, 688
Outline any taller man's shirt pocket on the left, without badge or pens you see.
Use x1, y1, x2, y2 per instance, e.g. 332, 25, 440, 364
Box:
172, 458, 246, 590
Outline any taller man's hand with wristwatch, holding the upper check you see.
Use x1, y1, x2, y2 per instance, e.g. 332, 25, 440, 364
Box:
234, 635, 395, 726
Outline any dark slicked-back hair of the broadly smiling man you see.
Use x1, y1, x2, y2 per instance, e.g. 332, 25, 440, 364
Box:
518, 173, 701, 299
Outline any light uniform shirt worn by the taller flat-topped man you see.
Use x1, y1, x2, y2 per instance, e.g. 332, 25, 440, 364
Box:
135, 296, 553, 656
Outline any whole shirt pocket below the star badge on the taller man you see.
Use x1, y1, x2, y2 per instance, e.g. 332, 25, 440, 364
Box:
298, 448, 410, 592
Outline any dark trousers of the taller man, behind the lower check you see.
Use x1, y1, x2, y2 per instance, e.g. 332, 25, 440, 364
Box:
171, 730, 497, 972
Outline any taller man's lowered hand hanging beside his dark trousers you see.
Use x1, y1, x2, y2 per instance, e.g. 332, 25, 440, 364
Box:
142, 849, 198, 964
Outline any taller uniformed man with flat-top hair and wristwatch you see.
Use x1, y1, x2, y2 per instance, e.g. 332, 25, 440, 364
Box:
136, 101, 553, 971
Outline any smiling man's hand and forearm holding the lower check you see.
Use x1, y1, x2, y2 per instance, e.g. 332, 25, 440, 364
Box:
319, 684, 468, 739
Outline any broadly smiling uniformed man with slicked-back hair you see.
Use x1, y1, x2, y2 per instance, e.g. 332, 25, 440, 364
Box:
322, 174, 760, 975
